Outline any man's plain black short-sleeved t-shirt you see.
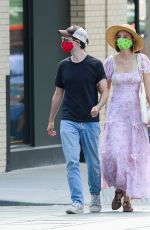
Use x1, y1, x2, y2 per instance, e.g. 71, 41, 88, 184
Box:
55, 55, 106, 122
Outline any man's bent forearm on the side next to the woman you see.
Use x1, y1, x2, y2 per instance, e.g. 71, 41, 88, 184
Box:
91, 79, 108, 117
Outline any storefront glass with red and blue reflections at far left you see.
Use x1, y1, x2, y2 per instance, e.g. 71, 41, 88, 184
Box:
10, 0, 25, 144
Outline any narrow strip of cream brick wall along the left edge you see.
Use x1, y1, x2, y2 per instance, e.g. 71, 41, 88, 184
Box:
0, 0, 9, 172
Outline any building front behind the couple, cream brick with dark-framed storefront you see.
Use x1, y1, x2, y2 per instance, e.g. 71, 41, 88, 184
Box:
0, 0, 146, 172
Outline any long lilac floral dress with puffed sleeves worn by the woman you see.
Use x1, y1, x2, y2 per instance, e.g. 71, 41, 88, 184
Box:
100, 54, 150, 198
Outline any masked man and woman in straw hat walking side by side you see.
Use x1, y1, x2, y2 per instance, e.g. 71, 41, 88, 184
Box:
47, 24, 150, 214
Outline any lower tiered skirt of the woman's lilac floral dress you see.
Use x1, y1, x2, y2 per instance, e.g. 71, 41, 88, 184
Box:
100, 121, 150, 198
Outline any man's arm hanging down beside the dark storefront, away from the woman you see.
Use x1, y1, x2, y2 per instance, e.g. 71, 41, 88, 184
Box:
47, 87, 64, 136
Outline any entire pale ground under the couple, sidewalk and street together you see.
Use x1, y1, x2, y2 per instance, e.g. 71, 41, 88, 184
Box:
0, 163, 150, 230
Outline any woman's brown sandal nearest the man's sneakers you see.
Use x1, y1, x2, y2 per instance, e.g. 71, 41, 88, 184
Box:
111, 189, 124, 210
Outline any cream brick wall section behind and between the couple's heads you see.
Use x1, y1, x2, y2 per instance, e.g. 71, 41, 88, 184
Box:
70, 0, 127, 128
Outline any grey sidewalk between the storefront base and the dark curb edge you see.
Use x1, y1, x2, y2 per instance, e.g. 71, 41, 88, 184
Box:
0, 163, 116, 205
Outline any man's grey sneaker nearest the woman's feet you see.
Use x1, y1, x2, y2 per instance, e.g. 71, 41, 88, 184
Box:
89, 195, 102, 212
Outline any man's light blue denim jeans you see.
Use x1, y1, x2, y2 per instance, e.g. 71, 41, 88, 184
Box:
60, 120, 101, 204
